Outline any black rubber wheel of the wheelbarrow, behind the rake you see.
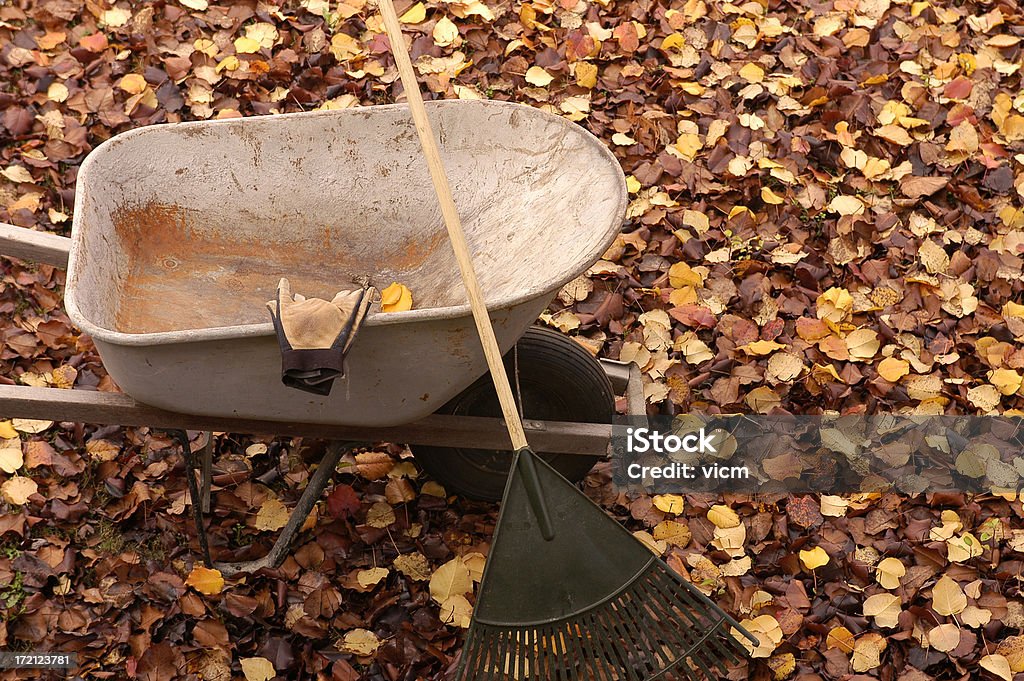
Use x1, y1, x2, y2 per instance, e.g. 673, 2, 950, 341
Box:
413, 327, 615, 501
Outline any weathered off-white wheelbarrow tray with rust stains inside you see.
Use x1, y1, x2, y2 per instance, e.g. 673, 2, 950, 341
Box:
66, 101, 627, 427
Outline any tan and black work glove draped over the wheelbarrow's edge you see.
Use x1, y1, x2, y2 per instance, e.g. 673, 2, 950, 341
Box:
266, 279, 376, 395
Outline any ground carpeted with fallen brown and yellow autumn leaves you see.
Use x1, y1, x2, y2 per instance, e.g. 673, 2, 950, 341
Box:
0, 0, 1024, 681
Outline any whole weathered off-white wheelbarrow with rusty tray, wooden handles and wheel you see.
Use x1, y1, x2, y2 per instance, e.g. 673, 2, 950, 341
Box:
0, 101, 643, 568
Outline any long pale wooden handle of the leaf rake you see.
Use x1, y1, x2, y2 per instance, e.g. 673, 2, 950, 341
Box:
377, 0, 529, 451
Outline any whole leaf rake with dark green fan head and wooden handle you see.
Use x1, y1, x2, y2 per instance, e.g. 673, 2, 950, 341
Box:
378, 0, 758, 681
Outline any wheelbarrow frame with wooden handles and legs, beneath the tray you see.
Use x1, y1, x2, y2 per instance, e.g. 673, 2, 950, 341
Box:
0, 218, 645, 573
